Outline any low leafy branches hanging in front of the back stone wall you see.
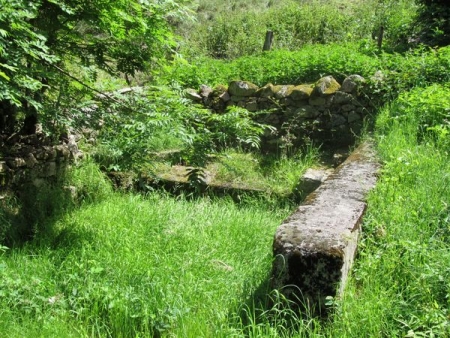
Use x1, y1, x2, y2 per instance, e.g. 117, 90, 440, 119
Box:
95, 87, 268, 174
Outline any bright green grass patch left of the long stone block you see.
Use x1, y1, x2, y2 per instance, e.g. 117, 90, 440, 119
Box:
0, 189, 296, 337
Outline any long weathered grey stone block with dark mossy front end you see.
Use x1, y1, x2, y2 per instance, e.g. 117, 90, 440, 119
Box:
272, 142, 379, 313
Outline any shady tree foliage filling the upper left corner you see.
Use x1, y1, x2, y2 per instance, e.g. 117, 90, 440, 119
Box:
0, 0, 179, 133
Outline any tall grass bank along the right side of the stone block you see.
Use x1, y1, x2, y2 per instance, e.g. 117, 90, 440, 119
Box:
326, 86, 450, 337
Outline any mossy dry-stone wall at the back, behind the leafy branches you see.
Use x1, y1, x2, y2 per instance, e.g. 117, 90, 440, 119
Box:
186, 75, 372, 146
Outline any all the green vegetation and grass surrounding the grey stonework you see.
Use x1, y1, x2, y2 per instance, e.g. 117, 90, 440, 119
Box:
0, 0, 450, 337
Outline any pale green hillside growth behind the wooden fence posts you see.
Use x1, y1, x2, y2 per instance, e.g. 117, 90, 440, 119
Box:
177, 0, 417, 59
